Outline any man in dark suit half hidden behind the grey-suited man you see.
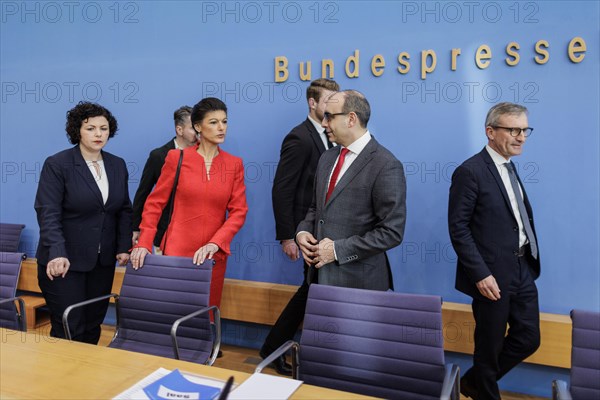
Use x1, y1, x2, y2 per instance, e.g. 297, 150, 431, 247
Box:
260, 79, 340, 375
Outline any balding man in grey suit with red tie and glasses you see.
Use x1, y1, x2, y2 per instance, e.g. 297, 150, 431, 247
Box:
296, 90, 406, 290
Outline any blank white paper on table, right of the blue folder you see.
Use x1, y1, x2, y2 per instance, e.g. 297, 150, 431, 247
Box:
228, 373, 302, 400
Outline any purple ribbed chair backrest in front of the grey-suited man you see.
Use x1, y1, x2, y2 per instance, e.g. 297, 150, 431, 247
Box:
299, 285, 445, 399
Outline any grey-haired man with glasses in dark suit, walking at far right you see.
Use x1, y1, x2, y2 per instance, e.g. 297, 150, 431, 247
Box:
448, 103, 540, 399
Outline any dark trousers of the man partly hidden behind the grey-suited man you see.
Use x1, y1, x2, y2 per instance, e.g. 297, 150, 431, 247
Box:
262, 263, 317, 354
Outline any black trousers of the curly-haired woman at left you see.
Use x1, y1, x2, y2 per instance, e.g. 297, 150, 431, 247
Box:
38, 264, 115, 344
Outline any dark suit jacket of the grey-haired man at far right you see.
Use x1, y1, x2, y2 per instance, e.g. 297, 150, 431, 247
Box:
448, 148, 540, 300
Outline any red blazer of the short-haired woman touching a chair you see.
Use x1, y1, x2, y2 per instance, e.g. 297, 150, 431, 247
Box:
138, 146, 248, 257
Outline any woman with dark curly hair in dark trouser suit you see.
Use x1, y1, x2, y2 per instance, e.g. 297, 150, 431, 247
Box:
35, 102, 132, 344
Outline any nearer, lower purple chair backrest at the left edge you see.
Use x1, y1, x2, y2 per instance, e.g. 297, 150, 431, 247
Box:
0, 252, 23, 329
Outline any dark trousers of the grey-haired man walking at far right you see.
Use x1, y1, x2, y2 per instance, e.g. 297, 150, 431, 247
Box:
464, 254, 540, 400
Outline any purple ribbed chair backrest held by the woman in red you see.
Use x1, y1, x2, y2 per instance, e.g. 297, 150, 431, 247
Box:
110, 255, 213, 363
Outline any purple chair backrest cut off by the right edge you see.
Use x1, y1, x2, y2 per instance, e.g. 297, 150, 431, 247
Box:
570, 310, 600, 399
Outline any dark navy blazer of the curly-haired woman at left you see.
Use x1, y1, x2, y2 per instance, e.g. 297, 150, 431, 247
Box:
35, 146, 131, 271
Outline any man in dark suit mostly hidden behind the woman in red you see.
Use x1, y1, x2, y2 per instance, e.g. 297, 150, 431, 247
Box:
132, 106, 196, 248
